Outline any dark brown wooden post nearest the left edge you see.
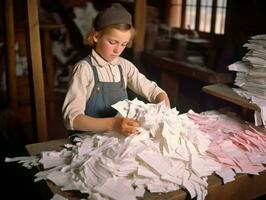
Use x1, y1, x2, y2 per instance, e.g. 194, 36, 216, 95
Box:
5, 0, 18, 112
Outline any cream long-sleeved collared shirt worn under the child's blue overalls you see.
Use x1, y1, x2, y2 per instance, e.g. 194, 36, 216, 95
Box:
62, 50, 164, 130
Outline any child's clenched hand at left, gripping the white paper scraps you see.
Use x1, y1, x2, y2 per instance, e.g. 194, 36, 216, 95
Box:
114, 117, 140, 136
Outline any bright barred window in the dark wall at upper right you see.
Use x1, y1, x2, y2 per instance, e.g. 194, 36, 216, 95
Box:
169, 0, 227, 34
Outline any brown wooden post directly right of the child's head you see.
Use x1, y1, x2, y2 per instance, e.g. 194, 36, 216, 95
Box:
133, 0, 147, 65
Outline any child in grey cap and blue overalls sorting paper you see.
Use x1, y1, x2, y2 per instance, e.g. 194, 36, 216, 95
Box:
62, 3, 170, 136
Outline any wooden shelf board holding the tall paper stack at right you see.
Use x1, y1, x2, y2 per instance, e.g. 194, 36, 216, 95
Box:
202, 84, 260, 111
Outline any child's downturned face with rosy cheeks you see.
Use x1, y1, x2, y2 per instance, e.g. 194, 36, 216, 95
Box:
94, 28, 131, 62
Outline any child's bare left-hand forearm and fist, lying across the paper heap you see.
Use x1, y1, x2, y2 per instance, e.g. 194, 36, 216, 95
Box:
73, 114, 139, 136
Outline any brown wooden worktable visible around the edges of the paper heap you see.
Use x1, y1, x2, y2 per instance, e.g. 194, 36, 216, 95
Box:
26, 139, 266, 200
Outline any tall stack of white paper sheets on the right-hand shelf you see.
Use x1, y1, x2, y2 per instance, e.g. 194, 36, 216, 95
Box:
228, 34, 266, 126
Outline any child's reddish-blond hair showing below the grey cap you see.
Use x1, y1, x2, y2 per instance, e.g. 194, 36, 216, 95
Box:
85, 24, 135, 48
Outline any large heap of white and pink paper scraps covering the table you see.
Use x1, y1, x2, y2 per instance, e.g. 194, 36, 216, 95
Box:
6, 99, 266, 200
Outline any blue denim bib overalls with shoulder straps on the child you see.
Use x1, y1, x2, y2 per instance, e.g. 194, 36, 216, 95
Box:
68, 56, 128, 136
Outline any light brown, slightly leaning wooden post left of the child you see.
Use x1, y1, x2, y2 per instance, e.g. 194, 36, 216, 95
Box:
26, 0, 48, 142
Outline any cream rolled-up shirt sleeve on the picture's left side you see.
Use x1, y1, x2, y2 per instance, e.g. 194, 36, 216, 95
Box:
62, 61, 94, 130
